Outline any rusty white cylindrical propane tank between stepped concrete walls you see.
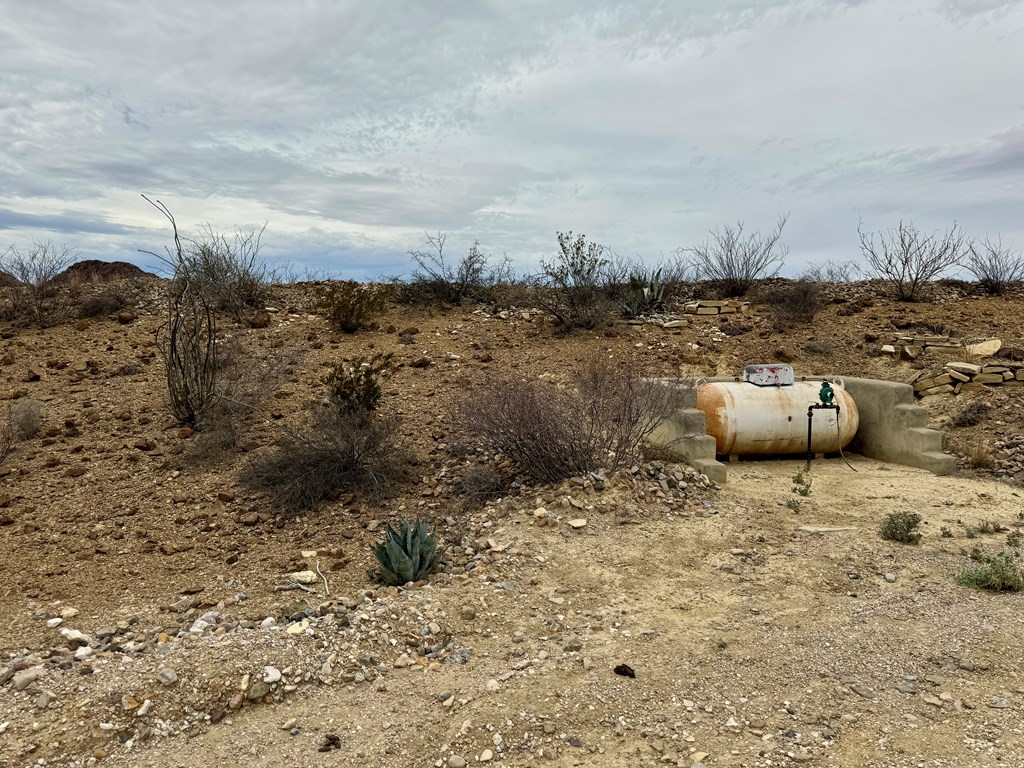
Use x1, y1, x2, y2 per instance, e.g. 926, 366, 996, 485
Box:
697, 380, 860, 456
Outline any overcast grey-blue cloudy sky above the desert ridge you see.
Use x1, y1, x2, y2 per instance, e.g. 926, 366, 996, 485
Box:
0, 0, 1024, 279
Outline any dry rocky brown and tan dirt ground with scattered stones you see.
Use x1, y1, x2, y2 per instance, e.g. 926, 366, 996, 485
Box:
0, 283, 1024, 768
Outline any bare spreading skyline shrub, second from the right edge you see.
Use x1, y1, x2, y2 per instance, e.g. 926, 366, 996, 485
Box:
857, 220, 971, 301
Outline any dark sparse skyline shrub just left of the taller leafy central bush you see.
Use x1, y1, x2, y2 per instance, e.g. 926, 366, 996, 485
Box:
401, 231, 514, 304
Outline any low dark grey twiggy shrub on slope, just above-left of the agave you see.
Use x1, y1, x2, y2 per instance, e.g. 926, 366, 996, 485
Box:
241, 409, 410, 514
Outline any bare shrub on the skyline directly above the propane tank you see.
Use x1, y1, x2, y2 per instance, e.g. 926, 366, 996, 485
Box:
685, 214, 790, 298
